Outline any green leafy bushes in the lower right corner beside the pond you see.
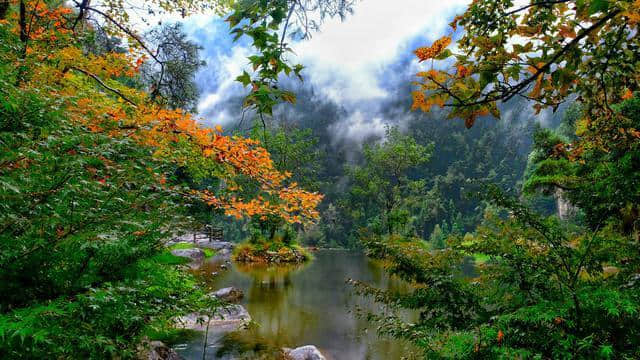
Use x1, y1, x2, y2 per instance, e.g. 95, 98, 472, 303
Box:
355, 187, 640, 359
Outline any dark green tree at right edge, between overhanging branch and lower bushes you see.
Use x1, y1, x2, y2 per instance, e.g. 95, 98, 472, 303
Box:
523, 96, 640, 236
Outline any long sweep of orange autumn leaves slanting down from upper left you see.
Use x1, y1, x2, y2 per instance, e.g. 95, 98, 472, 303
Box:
5, 1, 322, 223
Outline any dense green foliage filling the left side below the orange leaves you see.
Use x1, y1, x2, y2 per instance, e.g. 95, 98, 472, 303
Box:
0, 38, 206, 359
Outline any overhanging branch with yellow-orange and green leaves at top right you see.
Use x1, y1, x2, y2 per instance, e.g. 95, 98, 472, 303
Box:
413, 0, 640, 127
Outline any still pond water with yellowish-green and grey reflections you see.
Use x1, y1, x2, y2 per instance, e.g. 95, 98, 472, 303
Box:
179, 250, 422, 360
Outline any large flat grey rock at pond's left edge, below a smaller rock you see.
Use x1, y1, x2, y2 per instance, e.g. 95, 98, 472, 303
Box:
174, 305, 251, 331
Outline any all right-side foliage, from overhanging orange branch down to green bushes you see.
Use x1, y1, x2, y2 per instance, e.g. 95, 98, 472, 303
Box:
354, 1, 640, 359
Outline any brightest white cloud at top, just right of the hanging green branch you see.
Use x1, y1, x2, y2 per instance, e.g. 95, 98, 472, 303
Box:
293, 0, 469, 102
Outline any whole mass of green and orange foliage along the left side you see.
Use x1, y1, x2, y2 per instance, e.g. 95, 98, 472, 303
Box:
0, 1, 321, 359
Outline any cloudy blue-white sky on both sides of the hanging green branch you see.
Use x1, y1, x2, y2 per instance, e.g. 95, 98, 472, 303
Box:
175, 0, 469, 139
